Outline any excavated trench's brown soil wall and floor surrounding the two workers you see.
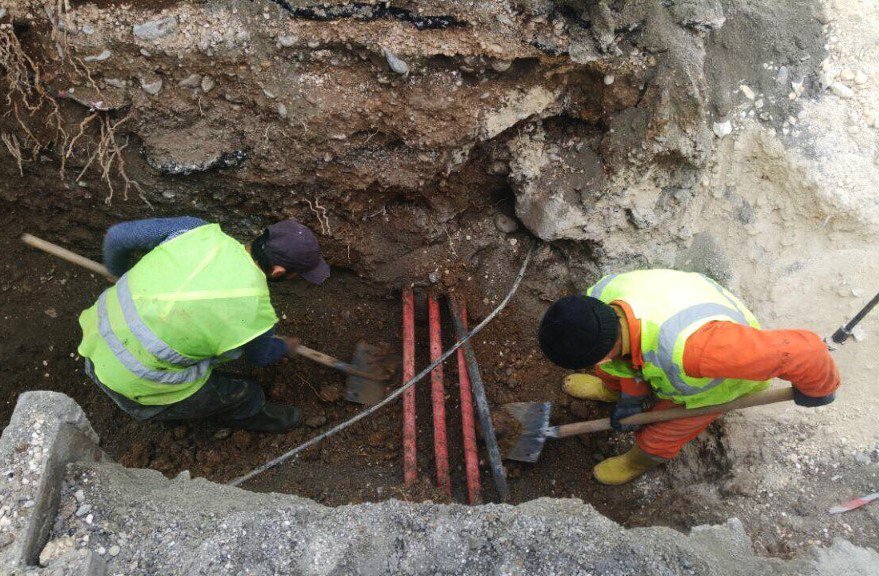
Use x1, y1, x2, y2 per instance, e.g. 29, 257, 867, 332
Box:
0, 0, 864, 554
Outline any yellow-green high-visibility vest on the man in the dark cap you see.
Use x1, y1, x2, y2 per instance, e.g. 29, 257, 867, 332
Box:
78, 224, 277, 406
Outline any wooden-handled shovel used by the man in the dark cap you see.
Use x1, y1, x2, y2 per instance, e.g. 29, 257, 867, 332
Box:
21, 234, 396, 404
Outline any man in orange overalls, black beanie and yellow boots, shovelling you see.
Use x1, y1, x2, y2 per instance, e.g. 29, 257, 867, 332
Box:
538, 270, 839, 485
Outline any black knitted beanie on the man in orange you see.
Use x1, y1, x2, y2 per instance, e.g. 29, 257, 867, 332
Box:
537, 296, 620, 370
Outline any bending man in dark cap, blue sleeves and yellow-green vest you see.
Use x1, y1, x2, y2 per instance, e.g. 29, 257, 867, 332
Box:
78, 217, 330, 432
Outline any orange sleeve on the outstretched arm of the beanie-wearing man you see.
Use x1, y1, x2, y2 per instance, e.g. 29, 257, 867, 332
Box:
684, 321, 839, 398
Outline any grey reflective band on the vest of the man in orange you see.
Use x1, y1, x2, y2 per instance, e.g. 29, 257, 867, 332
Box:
644, 302, 748, 396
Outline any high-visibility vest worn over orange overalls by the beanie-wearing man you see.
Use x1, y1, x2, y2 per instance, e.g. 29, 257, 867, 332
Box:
587, 270, 769, 408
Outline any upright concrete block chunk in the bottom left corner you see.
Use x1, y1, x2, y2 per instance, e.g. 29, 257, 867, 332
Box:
0, 391, 104, 574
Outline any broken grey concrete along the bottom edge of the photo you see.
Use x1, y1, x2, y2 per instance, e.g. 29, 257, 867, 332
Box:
0, 392, 879, 576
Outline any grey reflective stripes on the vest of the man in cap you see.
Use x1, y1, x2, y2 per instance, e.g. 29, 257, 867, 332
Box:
98, 287, 213, 385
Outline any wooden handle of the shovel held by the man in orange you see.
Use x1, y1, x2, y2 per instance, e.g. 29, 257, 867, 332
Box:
553, 387, 794, 438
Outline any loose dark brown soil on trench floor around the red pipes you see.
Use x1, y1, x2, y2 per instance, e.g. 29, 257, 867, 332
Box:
0, 203, 652, 522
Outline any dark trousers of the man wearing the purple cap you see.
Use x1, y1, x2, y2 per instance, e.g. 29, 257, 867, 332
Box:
86, 359, 266, 427
